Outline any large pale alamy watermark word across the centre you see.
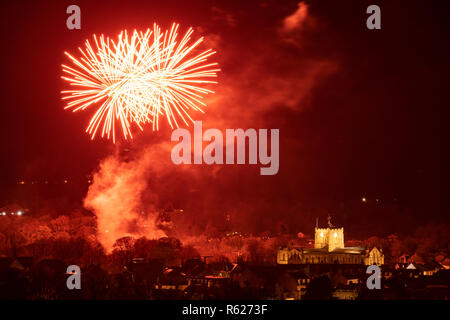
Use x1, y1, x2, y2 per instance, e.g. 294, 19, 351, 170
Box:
171, 121, 280, 175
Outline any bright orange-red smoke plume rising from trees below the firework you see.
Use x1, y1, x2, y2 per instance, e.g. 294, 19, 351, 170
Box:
84, 144, 169, 250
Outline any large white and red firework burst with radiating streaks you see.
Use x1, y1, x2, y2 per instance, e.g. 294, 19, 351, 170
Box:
62, 24, 220, 142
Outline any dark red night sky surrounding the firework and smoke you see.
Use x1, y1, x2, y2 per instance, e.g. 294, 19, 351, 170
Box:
0, 0, 450, 238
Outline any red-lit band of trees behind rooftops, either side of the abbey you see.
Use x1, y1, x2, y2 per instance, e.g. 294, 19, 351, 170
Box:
0, 212, 450, 269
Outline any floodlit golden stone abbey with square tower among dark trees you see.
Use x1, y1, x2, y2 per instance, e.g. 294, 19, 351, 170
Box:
277, 217, 384, 265
